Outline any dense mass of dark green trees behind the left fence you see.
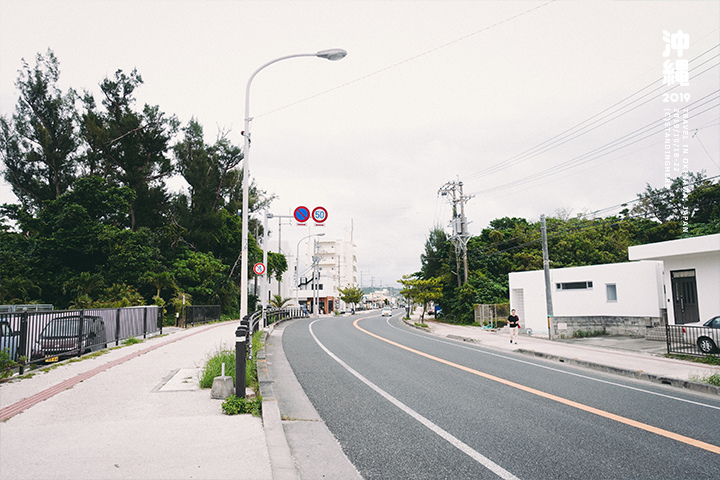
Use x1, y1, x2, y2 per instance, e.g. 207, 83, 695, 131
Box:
0, 50, 287, 316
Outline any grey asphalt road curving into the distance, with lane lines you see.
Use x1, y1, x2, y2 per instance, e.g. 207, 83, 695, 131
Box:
283, 312, 720, 480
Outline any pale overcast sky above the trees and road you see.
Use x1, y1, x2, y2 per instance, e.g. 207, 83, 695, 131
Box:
0, 0, 720, 286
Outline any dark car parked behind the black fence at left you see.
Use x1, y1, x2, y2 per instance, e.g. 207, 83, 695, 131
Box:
33, 315, 107, 362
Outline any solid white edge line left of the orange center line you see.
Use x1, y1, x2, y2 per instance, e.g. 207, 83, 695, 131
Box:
310, 320, 520, 480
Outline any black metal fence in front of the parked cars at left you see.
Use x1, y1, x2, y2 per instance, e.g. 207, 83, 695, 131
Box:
0, 306, 162, 373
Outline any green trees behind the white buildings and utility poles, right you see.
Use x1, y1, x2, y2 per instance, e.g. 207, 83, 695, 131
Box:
398, 172, 720, 325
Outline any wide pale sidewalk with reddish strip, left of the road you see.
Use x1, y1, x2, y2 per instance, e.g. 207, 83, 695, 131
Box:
0, 322, 273, 480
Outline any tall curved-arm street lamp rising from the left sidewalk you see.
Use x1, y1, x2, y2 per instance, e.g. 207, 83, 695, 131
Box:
240, 48, 347, 319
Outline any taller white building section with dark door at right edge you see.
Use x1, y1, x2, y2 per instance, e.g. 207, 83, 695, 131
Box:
628, 234, 720, 325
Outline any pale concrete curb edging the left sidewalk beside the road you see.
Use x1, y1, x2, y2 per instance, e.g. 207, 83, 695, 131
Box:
257, 320, 300, 480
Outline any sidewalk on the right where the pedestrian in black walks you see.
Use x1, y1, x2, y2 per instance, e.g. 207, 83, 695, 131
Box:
406, 315, 720, 395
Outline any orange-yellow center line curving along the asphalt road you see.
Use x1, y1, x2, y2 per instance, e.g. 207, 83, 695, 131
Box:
353, 318, 720, 454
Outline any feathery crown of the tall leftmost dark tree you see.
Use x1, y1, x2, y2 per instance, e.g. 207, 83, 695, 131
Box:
0, 50, 79, 211
